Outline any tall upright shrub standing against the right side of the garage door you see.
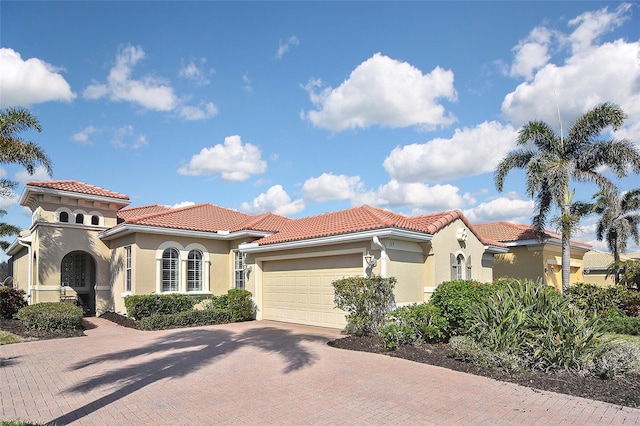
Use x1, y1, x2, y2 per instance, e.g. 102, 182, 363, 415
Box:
332, 276, 396, 335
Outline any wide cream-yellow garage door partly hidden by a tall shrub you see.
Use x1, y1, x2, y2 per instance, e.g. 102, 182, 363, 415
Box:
262, 254, 362, 328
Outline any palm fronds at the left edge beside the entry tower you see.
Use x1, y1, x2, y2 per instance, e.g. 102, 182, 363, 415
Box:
0, 108, 53, 197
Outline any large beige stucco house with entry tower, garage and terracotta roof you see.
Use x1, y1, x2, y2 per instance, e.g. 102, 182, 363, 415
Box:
7, 181, 507, 328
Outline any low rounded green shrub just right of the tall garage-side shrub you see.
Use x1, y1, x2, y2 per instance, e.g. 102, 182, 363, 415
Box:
380, 303, 449, 350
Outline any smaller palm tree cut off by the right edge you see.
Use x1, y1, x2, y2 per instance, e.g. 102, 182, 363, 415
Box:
593, 189, 640, 284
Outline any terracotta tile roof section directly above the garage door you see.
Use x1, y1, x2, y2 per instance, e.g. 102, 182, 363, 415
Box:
252, 205, 503, 246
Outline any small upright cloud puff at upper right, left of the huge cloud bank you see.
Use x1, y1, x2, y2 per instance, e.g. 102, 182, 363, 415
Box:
509, 27, 551, 79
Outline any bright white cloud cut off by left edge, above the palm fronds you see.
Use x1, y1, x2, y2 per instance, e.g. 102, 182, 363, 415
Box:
0, 48, 76, 108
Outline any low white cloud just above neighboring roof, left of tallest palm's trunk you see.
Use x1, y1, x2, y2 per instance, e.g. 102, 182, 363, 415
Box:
464, 197, 535, 224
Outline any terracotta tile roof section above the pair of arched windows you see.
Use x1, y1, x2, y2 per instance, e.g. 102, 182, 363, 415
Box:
120, 203, 290, 232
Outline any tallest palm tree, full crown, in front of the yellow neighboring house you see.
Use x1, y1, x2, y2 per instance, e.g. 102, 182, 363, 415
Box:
494, 103, 640, 291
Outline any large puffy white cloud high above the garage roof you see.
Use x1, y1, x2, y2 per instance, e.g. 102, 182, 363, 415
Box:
302, 53, 457, 131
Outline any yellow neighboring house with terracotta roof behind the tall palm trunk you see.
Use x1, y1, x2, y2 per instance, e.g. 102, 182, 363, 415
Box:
475, 222, 591, 290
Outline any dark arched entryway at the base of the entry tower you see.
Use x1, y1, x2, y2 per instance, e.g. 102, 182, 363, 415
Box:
60, 251, 96, 315
